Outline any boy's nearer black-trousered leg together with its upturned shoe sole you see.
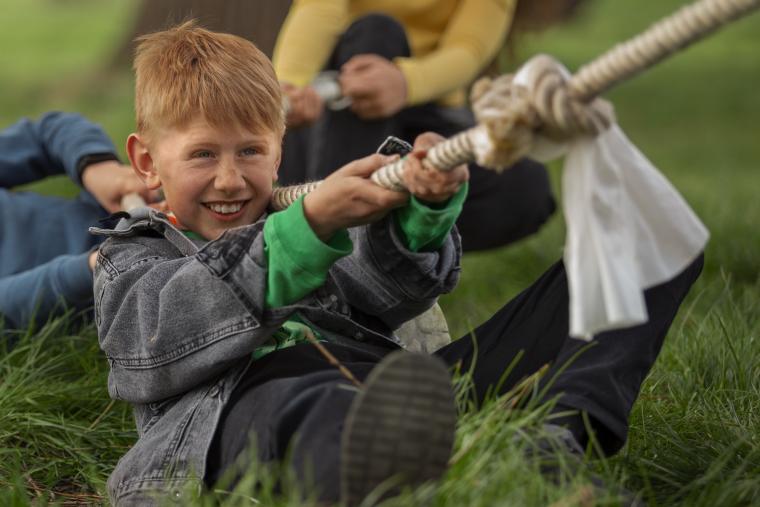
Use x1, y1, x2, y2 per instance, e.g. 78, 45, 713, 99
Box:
205, 345, 456, 505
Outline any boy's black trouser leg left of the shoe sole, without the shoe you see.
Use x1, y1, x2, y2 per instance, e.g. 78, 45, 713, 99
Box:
206, 370, 364, 500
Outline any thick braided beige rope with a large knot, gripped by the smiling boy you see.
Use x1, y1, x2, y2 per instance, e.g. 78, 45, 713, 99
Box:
272, 0, 760, 211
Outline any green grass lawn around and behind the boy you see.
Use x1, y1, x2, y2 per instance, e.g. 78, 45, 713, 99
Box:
0, 0, 760, 507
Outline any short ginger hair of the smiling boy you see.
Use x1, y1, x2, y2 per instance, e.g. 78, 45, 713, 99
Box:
134, 21, 285, 136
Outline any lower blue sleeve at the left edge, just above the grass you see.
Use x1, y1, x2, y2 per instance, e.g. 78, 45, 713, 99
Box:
0, 252, 93, 329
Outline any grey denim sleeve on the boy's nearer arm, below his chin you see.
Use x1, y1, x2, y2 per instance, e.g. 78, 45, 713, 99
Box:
94, 218, 284, 403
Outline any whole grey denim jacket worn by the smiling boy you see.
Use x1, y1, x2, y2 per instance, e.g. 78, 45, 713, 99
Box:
91, 208, 461, 505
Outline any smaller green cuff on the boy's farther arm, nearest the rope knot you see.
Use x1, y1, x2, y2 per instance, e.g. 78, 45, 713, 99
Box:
394, 183, 468, 252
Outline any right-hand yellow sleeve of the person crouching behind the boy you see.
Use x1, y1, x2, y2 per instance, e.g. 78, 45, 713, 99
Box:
394, 0, 516, 105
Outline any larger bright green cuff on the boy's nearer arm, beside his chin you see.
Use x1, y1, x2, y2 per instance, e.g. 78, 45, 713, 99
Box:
264, 198, 353, 308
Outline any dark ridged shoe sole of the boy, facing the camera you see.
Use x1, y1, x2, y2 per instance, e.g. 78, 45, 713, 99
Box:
340, 351, 457, 507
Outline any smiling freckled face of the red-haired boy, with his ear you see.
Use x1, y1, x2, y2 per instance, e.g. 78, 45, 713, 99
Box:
127, 118, 280, 240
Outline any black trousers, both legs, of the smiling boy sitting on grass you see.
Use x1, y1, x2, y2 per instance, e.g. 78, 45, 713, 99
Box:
206, 256, 703, 501
